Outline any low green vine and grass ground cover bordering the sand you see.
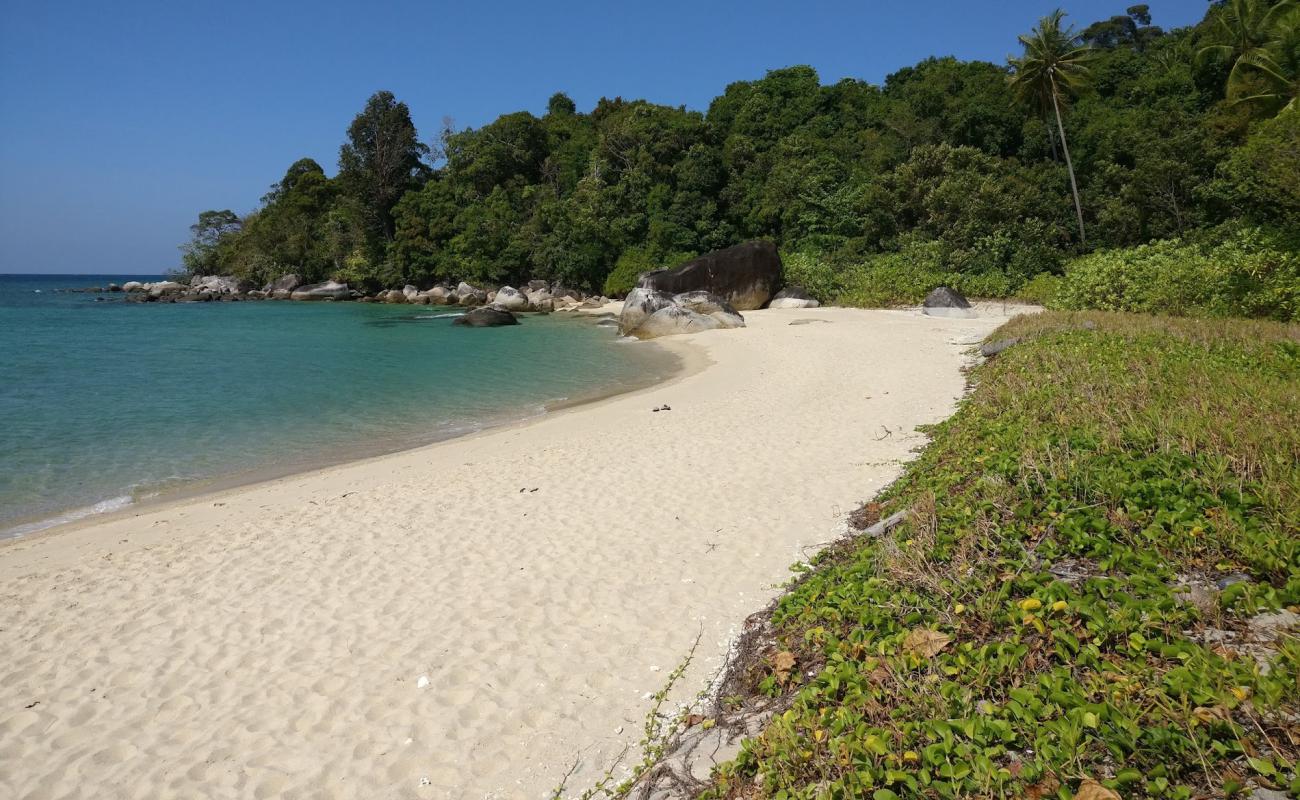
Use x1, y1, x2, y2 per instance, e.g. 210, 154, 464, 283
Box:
703, 312, 1300, 800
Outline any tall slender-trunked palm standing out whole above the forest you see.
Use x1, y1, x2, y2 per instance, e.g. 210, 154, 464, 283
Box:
1010, 9, 1092, 247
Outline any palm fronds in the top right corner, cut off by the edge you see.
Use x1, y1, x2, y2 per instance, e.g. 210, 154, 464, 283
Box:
1196, 0, 1300, 111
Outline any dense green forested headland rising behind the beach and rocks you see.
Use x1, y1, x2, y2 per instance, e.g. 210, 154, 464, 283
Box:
182, 0, 1300, 320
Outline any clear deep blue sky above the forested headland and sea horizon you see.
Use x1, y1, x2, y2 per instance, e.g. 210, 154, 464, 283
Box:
0, 0, 1206, 273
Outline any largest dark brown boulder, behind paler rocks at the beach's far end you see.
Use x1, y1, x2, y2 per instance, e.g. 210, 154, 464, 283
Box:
637, 242, 781, 311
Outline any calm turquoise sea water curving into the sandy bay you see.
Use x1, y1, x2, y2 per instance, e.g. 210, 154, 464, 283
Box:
0, 276, 675, 537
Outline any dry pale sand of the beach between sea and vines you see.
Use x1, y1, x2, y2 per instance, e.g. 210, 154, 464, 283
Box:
0, 307, 1034, 799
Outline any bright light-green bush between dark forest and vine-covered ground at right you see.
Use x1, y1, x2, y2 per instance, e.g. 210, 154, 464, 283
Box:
1054, 225, 1300, 320
